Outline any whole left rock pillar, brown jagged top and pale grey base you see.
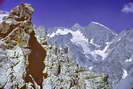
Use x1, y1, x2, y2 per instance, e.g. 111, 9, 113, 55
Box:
0, 4, 34, 89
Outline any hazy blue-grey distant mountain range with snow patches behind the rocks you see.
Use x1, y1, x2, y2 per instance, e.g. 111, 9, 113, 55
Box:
47, 22, 133, 89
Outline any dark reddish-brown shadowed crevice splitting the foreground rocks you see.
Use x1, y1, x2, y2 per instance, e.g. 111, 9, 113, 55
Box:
25, 32, 46, 89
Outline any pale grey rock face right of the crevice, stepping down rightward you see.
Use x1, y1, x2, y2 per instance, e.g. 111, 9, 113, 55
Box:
43, 47, 111, 89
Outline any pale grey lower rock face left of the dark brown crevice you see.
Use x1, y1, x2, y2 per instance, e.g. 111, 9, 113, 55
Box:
0, 47, 29, 89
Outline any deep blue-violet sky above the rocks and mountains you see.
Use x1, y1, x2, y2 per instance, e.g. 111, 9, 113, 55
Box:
0, 0, 133, 32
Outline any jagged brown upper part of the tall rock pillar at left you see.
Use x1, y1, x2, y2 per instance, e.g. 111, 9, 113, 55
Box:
0, 3, 34, 46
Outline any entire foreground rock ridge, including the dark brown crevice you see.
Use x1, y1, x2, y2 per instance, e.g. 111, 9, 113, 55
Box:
0, 3, 111, 89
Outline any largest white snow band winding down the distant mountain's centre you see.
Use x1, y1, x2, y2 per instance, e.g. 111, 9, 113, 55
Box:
48, 29, 112, 60
